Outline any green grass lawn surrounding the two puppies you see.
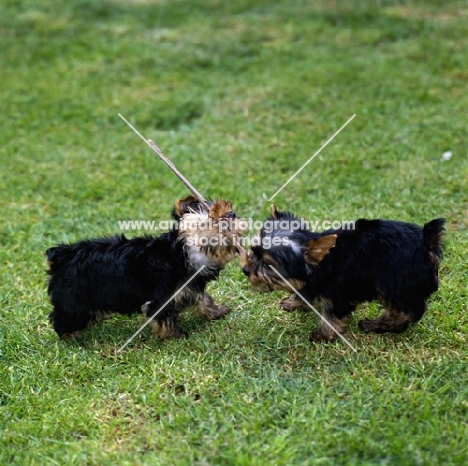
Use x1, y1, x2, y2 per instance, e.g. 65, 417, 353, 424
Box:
0, 0, 468, 465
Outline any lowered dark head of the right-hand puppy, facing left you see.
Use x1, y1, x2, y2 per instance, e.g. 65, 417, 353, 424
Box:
240, 205, 336, 291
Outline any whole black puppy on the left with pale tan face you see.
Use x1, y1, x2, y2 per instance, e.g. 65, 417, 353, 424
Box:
46, 196, 243, 339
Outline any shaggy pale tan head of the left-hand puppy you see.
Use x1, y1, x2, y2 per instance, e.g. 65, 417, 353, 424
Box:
172, 196, 246, 267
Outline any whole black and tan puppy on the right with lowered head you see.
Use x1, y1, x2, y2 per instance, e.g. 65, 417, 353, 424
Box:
241, 205, 445, 341
